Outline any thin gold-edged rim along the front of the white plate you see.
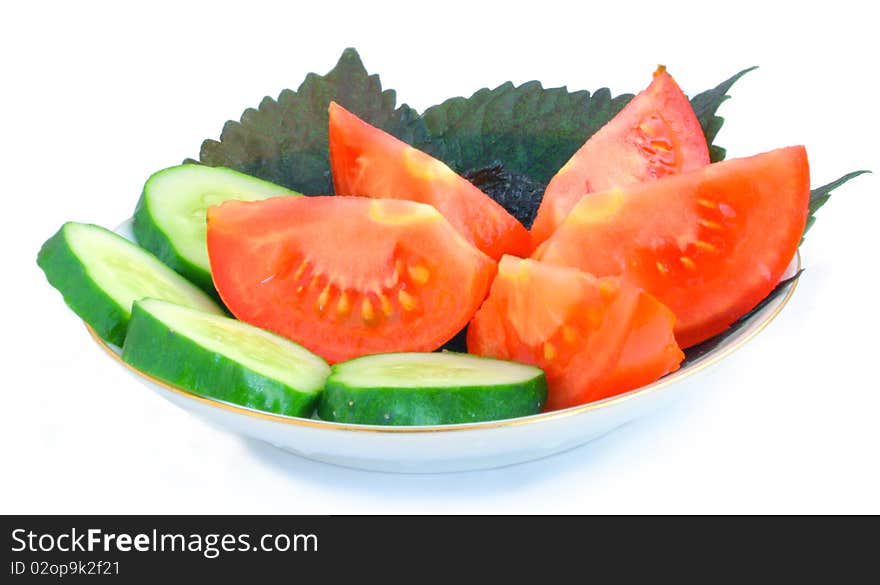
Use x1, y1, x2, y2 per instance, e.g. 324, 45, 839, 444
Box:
85, 251, 801, 433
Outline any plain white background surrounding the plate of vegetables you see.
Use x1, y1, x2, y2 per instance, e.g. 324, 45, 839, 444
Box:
0, 0, 880, 514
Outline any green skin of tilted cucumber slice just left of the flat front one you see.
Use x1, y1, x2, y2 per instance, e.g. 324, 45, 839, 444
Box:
122, 303, 321, 418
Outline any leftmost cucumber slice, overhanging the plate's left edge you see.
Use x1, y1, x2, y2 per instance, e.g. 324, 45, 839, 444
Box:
37, 222, 223, 345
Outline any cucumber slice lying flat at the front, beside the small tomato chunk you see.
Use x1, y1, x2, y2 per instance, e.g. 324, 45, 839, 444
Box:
318, 352, 547, 425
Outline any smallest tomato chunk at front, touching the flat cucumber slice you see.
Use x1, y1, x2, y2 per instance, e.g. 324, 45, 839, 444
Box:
467, 256, 684, 410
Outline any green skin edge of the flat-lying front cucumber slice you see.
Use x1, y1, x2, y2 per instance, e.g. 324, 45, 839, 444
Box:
318, 366, 547, 426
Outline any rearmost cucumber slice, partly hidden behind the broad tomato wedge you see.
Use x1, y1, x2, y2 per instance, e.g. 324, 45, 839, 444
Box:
134, 164, 299, 294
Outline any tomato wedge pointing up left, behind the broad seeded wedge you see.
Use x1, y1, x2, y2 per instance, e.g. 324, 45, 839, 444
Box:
330, 103, 532, 260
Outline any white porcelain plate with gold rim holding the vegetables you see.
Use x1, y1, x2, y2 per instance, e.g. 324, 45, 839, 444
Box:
89, 220, 800, 473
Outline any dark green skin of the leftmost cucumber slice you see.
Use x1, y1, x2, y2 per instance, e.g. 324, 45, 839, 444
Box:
37, 222, 131, 346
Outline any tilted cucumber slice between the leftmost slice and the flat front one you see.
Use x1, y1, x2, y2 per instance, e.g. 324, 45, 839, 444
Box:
122, 299, 330, 417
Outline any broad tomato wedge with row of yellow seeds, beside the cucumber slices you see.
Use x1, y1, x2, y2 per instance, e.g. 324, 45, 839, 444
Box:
208, 196, 496, 362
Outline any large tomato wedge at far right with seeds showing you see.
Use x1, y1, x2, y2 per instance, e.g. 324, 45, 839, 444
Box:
534, 146, 810, 347
